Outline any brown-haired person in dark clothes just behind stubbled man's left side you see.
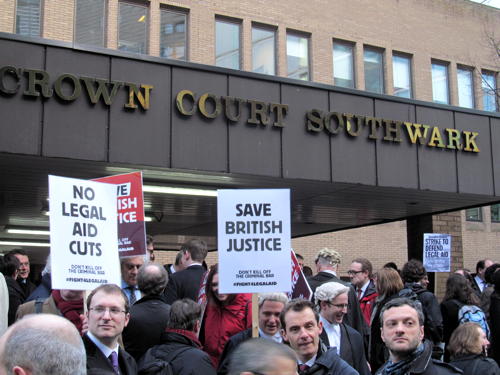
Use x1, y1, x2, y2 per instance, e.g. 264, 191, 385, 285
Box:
368, 268, 403, 373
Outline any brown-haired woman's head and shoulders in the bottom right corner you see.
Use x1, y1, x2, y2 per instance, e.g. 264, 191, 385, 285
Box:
448, 322, 500, 375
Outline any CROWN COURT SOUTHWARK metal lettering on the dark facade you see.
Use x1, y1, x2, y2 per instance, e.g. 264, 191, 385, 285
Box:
0, 65, 480, 153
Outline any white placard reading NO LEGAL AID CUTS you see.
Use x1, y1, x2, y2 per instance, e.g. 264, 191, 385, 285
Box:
49, 176, 121, 290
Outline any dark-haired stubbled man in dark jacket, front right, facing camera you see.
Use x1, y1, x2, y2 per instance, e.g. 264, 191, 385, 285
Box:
376, 298, 461, 375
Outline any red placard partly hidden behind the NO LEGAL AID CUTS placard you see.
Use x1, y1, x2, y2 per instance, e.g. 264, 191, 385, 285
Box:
94, 172, 146, 257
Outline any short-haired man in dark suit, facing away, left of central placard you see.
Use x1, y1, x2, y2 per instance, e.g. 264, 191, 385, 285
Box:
165, 239, 207, 305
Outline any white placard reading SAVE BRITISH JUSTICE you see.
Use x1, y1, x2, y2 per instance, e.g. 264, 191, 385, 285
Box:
217, 189, 291, 293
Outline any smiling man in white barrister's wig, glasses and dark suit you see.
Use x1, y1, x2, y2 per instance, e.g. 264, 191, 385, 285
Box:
315, 282, 370, 375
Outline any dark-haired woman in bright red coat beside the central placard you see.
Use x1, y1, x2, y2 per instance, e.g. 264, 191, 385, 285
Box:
200, 264, 252, 368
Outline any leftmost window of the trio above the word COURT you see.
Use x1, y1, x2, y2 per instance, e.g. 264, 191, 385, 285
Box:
215, 20, 240, 69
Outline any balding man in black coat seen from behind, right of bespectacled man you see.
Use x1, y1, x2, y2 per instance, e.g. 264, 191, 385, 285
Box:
122, 263, 170, 361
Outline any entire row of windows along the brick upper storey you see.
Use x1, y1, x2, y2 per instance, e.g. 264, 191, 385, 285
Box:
16, 0, 497, 111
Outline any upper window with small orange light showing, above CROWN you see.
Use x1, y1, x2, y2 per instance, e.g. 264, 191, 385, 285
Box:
118, 2, 148, 53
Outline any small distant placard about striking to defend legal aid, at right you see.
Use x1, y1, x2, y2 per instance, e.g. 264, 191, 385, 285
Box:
423, 233, 451, 272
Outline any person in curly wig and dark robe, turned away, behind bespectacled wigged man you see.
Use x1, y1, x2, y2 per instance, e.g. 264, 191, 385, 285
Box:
307, 247, 370, 349
